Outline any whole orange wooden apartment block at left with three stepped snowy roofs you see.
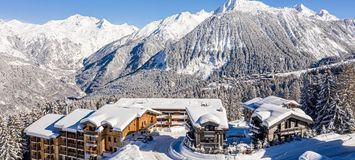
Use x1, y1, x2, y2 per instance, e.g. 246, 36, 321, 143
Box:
25, 105, 160, 160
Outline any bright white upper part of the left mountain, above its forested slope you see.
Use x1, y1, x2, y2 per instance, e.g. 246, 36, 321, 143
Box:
0, 15, 138, 70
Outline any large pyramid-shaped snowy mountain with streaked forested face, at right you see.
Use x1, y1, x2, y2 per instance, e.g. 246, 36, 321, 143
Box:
145, 0, 355, 77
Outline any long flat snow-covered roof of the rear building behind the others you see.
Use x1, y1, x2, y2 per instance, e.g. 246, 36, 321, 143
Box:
117, 98, 220, 110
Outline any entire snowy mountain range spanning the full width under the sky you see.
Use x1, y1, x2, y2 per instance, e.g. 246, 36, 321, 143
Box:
0, 0, 355, 115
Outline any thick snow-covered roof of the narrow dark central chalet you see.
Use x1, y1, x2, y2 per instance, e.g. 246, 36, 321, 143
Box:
186, 100, 229, 129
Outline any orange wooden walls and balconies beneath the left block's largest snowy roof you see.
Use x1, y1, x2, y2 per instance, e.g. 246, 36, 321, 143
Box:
82, 108, 158, 160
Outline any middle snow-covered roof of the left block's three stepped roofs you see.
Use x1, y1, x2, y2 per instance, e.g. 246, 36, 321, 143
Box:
54, 109, 94, 132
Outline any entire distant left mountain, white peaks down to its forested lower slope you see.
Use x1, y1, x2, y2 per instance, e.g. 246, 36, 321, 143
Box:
0, 15, 138, 112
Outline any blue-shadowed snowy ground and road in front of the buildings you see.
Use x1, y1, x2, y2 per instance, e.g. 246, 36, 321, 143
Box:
108, 121, 355, 160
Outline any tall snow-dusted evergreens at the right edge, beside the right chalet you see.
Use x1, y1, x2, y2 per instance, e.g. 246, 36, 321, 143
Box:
301, 68, 355, 134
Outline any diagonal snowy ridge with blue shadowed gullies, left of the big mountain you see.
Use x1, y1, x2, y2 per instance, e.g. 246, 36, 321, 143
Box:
77, 10, 212, 91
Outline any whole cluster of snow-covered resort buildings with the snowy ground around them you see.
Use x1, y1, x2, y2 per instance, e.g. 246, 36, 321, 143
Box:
25, 96, 355, 160
